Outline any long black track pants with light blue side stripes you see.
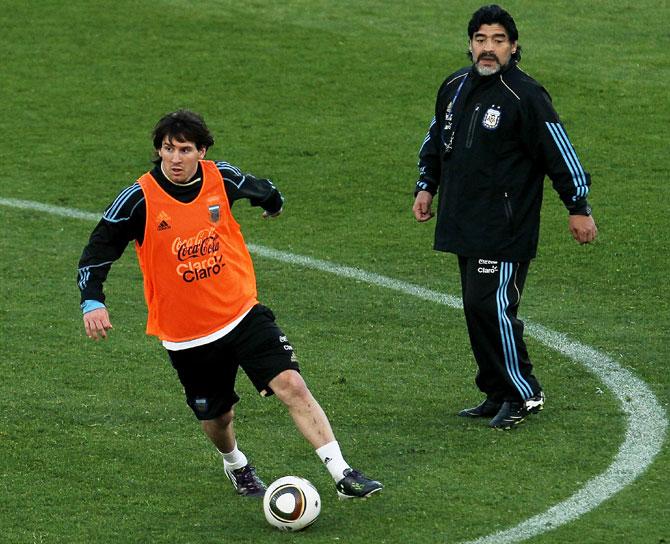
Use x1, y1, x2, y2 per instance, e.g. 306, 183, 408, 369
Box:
458, 256, 541, 401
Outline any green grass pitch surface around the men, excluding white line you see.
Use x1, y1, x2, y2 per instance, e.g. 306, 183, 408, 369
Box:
0, 0, 670, 544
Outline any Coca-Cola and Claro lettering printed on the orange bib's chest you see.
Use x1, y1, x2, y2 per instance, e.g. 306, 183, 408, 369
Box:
172, 228, 226, 283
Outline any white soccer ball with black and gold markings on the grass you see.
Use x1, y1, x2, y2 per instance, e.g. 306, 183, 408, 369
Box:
263, 476, 321, 531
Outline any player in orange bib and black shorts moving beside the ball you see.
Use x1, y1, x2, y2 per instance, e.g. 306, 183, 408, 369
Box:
78, 110, 383, 498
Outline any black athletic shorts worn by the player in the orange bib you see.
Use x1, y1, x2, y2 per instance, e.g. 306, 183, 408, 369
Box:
168, 304, 300, 420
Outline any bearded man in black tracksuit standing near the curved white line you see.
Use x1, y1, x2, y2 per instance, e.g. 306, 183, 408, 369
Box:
413, 5, 597, 429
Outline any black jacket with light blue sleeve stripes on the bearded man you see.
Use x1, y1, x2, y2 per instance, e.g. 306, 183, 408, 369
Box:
415, 61, 591, 262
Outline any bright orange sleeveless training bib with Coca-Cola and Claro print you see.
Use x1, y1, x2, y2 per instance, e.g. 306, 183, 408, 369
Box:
135, 161, 258, 342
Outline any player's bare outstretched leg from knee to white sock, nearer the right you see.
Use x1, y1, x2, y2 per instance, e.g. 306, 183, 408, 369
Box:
269, 370, 335, 449
